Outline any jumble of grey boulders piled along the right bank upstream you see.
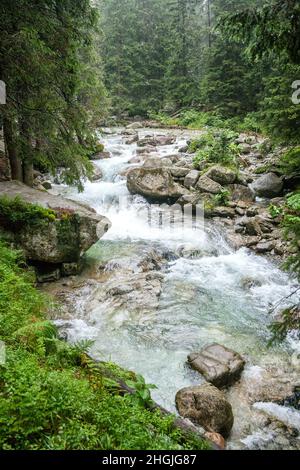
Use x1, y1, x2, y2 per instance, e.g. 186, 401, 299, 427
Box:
120, 124, 293, 258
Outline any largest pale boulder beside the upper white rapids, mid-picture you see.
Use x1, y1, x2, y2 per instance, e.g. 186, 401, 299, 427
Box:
127, 167, 184, 202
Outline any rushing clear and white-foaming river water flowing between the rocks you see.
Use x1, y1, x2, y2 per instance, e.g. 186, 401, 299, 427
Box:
52, 126, 300, 449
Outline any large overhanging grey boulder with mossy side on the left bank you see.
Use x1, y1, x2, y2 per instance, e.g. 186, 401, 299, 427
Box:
0, 181, 110, 265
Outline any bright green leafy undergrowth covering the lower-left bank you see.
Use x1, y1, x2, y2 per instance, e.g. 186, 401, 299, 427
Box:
0, 242, 208, 450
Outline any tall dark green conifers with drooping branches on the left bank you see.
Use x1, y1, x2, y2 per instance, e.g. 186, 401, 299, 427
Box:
0, 0, 106, 186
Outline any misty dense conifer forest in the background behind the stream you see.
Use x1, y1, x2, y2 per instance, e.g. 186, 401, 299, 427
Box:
100, 0, 300, 142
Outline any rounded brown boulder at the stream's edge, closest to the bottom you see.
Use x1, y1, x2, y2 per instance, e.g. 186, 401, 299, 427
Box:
175, 383, 234, 437
